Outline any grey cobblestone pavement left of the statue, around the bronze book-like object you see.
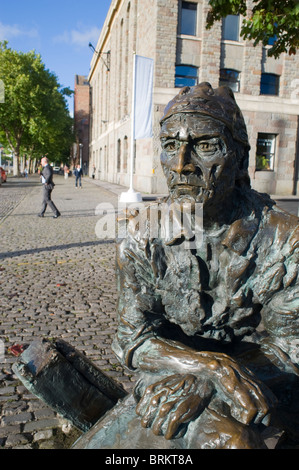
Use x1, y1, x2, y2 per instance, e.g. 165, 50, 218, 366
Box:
0, 176, 137, 449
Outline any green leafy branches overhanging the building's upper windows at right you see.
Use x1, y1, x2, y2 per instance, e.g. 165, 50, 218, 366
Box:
207, 0, 299, 58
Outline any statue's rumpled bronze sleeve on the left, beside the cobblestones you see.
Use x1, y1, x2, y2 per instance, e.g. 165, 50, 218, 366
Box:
112, 232, 165, 369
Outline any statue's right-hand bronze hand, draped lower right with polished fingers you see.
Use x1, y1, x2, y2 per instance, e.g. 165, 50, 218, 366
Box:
204, 353, 277, 425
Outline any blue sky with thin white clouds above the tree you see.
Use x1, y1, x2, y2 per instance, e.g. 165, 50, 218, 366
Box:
0, 0, 111, 113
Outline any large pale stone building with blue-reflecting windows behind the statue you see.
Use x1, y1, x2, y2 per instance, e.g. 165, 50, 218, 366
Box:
88, 0, 299, 195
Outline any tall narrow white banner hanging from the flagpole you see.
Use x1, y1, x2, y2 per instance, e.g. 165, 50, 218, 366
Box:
134, 55, 154, 140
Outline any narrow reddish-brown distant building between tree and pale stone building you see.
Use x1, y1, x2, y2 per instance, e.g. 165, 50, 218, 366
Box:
73, 75, 90, 174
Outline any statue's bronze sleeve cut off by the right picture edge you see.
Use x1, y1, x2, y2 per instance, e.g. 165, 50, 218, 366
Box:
259, 218, 299, 375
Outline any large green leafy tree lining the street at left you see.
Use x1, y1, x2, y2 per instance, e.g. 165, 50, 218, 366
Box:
0, 41, 73, 173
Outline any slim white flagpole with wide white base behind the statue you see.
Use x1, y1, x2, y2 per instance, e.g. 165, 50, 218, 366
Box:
119, 52, 142, 203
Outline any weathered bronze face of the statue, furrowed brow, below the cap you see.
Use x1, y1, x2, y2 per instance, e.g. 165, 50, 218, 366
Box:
161, 113, 237, 204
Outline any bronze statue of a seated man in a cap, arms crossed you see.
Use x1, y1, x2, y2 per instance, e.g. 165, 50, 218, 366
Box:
113, 83, 299, 448
